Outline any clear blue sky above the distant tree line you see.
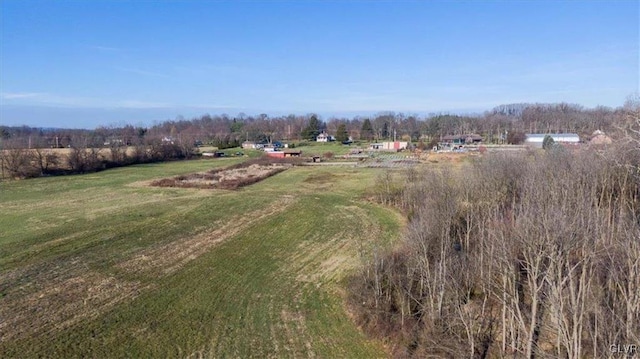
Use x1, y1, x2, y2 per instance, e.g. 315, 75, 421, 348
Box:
0, 0, 640, 128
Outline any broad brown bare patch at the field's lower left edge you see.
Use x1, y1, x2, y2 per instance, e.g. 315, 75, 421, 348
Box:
0, 259, 143, 343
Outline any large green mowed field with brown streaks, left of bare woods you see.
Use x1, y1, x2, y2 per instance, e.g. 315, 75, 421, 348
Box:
0, 159, 402, 358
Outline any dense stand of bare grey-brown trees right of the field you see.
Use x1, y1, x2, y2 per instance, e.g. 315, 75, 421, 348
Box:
350, 112, 640, 359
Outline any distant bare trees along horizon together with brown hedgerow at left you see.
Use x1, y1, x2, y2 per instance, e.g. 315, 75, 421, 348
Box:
0, 98, 638, 177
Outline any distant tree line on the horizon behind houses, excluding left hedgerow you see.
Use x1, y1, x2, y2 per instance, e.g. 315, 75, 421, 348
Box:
0, 99, 638, 148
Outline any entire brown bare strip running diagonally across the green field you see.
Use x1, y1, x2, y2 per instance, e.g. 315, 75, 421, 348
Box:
0, 196, 295, 346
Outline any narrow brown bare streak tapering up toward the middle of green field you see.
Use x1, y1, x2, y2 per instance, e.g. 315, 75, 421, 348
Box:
118, 196, 294, 275
